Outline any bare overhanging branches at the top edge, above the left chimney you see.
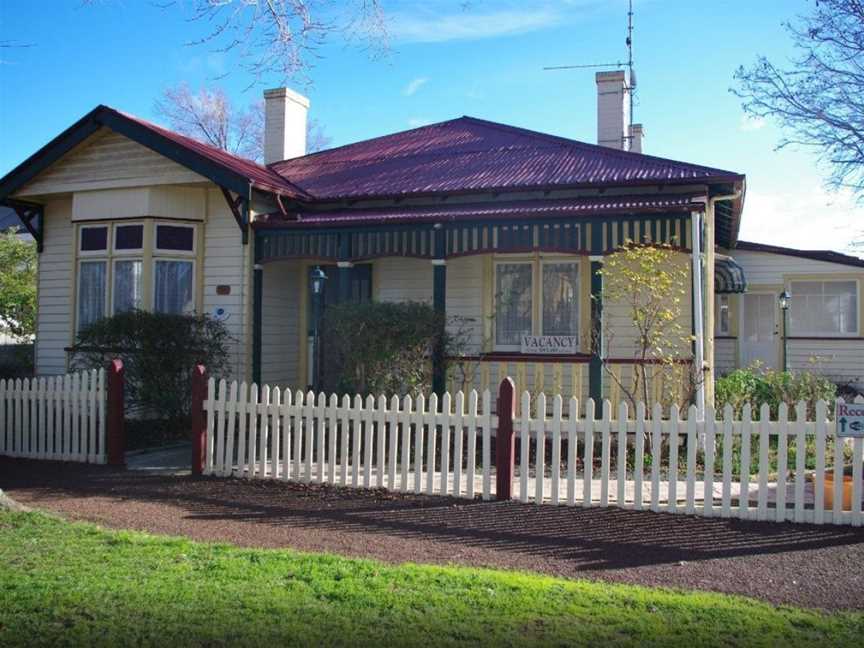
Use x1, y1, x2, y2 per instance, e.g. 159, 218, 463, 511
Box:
84, 0, 389, 86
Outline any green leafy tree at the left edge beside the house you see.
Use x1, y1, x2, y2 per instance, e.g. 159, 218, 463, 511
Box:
0, 228, 37, 338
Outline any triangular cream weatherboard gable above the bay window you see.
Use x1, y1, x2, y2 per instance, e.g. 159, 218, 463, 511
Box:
16, 128, 205, 196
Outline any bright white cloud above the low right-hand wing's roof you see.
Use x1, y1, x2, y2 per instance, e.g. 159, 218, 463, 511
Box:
740, 185, 864, 255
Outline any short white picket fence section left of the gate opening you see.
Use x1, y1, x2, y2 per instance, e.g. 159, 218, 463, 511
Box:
0, 369, 106, 463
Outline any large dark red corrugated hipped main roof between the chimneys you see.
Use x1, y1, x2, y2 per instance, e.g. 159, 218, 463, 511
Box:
270, 117, 744, 200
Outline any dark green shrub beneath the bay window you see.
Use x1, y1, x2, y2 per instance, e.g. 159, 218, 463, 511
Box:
71, 311, 231, 421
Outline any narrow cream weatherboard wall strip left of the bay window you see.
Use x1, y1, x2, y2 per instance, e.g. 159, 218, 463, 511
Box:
36, 198, 75, 376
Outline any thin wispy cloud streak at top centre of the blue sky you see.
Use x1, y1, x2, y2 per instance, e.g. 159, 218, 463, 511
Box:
390, 7, 560, 43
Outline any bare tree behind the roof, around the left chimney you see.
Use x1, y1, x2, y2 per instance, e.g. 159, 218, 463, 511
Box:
154, 83, 330, 162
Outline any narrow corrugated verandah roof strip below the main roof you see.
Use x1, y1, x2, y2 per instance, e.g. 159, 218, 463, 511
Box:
254, 194, 705, 227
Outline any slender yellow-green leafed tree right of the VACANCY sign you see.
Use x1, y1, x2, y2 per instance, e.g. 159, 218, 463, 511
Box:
593, 241, 699, 408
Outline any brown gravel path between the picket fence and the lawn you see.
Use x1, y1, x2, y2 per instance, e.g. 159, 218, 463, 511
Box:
0, 458, 864, 609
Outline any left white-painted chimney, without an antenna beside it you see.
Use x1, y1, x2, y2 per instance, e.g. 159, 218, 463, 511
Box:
264, 88, 309, 164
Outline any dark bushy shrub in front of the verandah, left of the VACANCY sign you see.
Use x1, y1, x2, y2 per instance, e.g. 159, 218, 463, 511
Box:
321, 302, 447, 395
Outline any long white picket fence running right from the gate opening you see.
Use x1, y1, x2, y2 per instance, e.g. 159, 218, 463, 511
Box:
204, 379, 864, 525
